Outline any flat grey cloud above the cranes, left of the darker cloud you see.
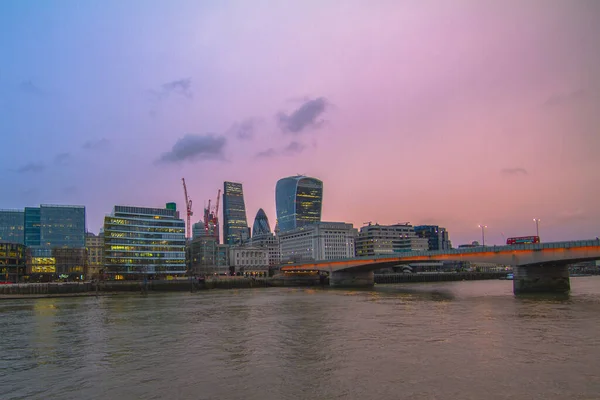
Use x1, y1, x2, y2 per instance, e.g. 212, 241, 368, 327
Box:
158, 134, 226, 163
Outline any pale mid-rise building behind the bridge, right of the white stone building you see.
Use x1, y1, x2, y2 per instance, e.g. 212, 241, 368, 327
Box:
356, 224, 429, 257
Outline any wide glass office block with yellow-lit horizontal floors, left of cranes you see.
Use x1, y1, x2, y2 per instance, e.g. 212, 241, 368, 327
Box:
104, 206, 186, 279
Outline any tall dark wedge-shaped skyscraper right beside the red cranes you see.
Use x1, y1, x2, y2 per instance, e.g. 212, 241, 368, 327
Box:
223, 182, 250, 245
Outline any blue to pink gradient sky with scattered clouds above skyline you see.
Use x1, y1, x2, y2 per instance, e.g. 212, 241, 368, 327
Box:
0, 0, 600, 246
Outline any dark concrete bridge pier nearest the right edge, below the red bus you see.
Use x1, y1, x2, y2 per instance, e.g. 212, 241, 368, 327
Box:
513, 265, 571, 294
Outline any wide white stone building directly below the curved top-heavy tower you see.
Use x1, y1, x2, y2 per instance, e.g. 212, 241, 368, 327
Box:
279, 222, 357, 263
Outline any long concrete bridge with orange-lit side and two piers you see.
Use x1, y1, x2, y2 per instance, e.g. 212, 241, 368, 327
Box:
281, 239, 600, 294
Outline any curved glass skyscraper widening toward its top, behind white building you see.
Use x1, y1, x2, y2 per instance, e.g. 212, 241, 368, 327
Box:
275, 175, 323, 232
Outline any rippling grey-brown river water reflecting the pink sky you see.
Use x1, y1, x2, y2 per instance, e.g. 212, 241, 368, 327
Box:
0, 277, 600, 400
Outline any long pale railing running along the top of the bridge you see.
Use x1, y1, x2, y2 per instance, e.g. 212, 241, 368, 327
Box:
283, 239, 600, 267
